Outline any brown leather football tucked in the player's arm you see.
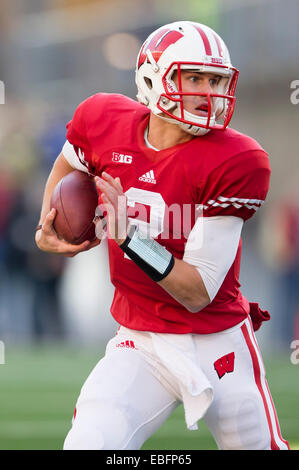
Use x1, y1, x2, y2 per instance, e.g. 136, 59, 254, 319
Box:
50, 170, 98, 245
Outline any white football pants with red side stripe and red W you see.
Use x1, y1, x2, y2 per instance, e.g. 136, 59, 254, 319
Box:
64, 319, 289, 450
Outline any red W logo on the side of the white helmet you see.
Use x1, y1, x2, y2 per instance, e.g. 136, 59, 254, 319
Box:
138, 28, 184, 68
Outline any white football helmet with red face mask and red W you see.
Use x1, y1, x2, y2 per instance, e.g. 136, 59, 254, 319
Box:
136, 21, 239, 135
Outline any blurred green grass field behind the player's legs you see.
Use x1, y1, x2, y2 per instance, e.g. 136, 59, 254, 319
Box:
0, 345, 299, 450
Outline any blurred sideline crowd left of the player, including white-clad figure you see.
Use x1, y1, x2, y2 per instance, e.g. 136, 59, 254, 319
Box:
0, 99, 115, 344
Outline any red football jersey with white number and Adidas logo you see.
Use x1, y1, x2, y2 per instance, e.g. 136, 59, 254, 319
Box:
67, 93, 270, 334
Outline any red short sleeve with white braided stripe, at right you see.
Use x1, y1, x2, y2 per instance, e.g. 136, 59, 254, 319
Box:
200, 150, 271, 221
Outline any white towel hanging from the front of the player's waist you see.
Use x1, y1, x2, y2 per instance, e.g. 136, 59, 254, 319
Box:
150, 333, 213, 430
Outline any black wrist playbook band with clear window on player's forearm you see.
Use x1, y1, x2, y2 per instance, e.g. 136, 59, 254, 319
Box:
120, 225, 174, 282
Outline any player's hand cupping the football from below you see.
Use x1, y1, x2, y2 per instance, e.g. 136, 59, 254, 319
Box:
35, 209, 101, 258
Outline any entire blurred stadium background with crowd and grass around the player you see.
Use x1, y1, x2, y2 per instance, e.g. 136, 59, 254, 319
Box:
0, 0, 299, 449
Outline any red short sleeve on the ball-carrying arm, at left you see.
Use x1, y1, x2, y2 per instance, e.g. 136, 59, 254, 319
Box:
66, 98, 94, 173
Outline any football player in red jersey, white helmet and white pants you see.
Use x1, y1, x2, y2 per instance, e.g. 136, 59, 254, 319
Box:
36, 21, 288, 450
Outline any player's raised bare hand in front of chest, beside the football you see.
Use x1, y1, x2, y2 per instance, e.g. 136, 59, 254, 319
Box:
95, 171, 128, 245
